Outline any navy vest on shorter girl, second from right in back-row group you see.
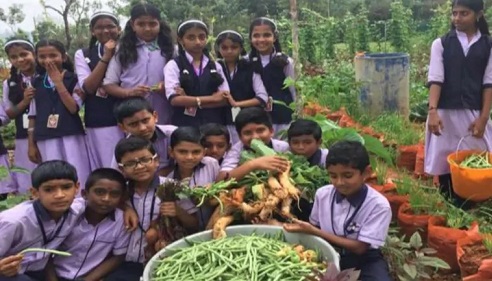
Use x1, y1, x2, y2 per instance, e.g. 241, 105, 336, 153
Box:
219, 60, 256, 125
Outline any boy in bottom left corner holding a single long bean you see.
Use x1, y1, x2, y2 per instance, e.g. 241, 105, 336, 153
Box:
0, 160, 85, 281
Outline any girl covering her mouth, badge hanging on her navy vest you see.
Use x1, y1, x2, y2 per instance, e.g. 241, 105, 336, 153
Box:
28, 39, 90, 186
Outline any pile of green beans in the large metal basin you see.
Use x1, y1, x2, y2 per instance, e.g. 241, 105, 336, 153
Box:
151, 235, 324, 281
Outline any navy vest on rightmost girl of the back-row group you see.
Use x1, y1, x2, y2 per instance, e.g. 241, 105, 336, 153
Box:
258, 59, 294, 124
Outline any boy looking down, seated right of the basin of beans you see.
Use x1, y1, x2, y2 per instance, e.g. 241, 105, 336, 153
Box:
284, 141, 391, 281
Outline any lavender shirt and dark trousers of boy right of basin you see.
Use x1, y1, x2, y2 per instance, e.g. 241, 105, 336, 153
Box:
310, 185, 391, 281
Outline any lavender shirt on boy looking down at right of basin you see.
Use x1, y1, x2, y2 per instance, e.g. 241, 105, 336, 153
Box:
309, 185, 391, 249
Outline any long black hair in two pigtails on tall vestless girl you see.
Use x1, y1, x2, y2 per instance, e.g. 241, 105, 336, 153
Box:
118, 3, 174, 69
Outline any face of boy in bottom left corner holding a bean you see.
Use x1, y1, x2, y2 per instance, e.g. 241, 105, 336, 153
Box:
31, 179, 79, 217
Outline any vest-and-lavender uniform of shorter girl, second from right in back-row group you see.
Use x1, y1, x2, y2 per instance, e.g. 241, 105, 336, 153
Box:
218, 59, 268, 144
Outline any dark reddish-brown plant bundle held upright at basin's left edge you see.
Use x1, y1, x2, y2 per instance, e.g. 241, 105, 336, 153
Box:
145, 180, 186, 258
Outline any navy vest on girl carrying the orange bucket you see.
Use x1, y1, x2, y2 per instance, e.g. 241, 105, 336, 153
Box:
437, 30, 491, 110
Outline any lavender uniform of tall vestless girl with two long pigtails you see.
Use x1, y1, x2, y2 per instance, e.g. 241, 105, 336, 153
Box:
103, 39, 172, 125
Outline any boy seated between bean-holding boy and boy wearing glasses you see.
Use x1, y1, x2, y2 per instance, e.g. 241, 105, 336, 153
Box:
53, 168, 130, 281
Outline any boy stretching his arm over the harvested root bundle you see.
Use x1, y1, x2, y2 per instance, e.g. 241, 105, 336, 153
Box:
218, 107, 289, 180
